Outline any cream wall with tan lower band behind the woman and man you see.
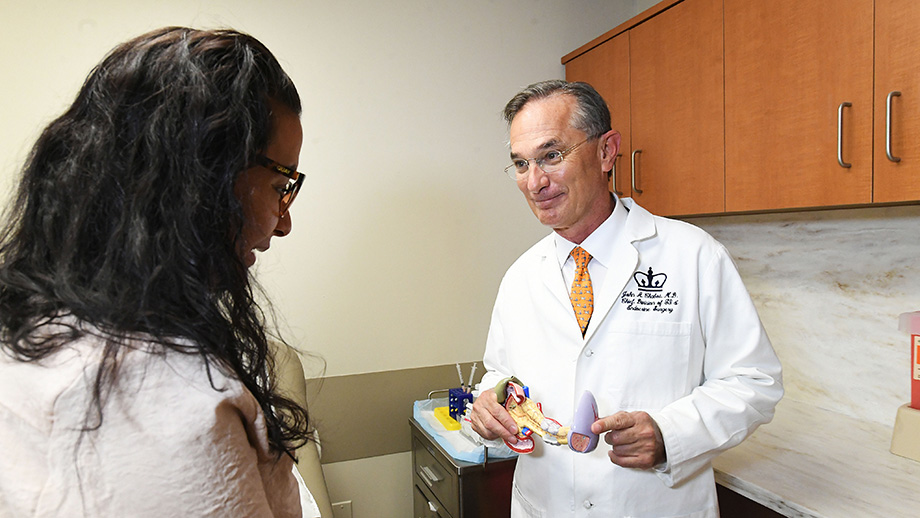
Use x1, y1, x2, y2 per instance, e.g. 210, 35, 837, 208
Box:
0, 0, 650, 517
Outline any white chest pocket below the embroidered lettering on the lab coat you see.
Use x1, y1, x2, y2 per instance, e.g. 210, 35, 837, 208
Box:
600, 320, 698, 410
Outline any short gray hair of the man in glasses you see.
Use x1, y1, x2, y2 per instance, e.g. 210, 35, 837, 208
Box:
502, 79, 610, 137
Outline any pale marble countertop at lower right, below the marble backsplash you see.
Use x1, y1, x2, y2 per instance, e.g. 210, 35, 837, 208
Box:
713, 399, 920, 518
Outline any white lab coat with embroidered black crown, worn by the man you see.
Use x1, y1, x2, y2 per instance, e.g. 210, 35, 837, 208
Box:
482, 198, 783, 518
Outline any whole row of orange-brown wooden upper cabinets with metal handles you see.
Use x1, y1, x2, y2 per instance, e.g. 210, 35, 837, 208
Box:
563, 0, 920, 215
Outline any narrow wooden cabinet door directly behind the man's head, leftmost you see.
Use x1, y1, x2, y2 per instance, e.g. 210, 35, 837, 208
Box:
565, 33, 632, 197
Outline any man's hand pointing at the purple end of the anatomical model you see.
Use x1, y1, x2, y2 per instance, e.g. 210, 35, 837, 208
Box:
591, 412, 666, 469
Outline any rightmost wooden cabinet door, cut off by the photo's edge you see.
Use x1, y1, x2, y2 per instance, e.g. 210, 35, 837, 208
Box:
873, 0, 920, 202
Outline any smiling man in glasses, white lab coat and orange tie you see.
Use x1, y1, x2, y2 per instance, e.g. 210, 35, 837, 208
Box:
471, 81, 783, 518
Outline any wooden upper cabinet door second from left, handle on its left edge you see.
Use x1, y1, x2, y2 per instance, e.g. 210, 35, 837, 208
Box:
623, 0, 725, 215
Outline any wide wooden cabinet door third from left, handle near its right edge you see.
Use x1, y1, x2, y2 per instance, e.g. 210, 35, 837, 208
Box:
724, 0, 868, 211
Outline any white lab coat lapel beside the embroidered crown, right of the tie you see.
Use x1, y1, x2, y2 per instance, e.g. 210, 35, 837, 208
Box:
585, 198, 657, 342
